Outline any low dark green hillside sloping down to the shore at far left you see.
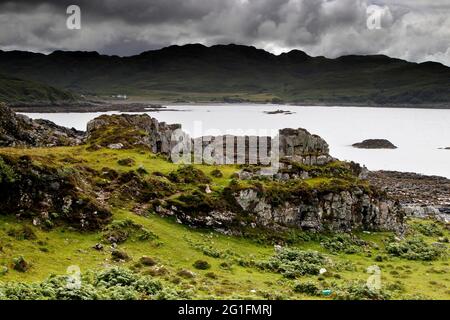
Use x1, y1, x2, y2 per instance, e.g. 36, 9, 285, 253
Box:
0, 74, 76, 103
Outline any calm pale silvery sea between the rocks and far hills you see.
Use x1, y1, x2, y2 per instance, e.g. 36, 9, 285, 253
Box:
22, 104, 450, 178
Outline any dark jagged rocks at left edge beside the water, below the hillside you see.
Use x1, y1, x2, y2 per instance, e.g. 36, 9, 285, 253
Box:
0, 103, 84, 147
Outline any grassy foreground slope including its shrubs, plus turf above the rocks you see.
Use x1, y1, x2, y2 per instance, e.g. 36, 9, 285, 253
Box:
0, 146, 450, 299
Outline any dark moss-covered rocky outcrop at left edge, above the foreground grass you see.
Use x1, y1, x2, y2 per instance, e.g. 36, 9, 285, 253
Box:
0, 155, 111, 230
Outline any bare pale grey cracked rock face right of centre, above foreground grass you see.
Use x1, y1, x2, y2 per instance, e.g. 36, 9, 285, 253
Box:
237, 190, 403, 231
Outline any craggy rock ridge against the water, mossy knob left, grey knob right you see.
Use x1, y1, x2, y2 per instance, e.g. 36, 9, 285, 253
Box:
87, 115, 335, 165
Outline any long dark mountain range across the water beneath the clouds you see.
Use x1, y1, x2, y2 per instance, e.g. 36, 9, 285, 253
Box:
0, 44, 450, 104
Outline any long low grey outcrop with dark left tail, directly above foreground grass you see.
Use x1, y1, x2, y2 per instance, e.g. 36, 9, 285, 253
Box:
159, 188, 405, 233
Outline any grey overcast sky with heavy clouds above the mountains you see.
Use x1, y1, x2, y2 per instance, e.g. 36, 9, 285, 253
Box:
0, 0, 450, 66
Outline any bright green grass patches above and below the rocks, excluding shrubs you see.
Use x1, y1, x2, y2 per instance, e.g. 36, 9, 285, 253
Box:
0, 146, 450, 299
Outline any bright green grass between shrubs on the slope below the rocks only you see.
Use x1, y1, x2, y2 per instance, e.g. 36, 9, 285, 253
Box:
0, 210, 450, 299
